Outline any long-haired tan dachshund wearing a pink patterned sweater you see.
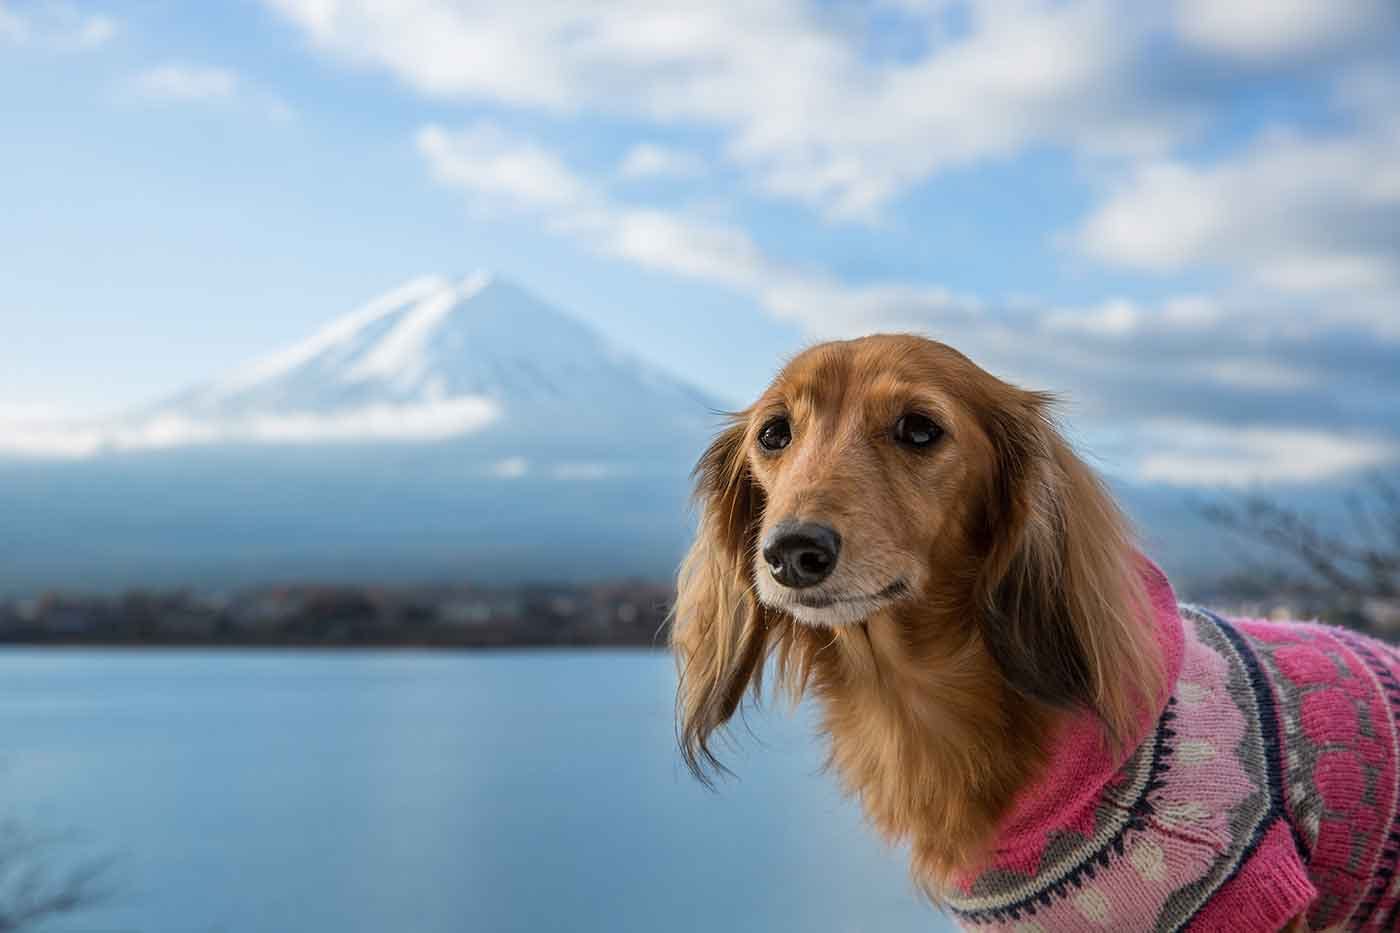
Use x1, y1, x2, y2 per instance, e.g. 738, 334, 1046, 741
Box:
672, 336, 1400, 933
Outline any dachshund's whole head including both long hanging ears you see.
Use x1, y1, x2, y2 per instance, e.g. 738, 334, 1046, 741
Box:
673, 336, 1151, 765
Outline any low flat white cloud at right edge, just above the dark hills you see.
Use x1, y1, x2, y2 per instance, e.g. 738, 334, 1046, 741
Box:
1135, 420, 1400, 486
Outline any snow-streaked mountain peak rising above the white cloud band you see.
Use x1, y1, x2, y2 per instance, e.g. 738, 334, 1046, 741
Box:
171, 273, 707, 433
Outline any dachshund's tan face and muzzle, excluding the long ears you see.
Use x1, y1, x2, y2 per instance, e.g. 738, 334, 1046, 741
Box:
735, 338, 1019, 626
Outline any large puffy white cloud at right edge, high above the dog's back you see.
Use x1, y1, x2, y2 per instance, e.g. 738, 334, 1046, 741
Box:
1075, 125, 1400, 326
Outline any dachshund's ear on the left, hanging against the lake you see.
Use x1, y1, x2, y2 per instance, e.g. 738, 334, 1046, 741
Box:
671, 415, 769, 783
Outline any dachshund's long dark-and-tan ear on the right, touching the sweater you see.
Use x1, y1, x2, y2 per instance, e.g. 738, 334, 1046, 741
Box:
979, 392, 1165, 741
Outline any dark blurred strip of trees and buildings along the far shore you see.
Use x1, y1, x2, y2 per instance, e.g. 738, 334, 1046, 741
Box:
0, 581, 673, 649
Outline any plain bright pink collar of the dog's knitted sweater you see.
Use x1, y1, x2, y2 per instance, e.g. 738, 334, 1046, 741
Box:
966, 558, 1184, 883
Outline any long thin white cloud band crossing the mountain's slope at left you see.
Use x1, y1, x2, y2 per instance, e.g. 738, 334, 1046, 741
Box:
0, 396, 500, 459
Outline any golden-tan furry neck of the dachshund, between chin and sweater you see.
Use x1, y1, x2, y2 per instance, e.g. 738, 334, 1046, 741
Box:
813, 607, 1057, 894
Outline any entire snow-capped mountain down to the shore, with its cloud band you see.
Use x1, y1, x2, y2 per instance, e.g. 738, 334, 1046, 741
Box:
0, 275, 722, 593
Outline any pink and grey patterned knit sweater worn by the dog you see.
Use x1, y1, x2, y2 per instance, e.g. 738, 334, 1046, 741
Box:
948, 565, 1400, 933
